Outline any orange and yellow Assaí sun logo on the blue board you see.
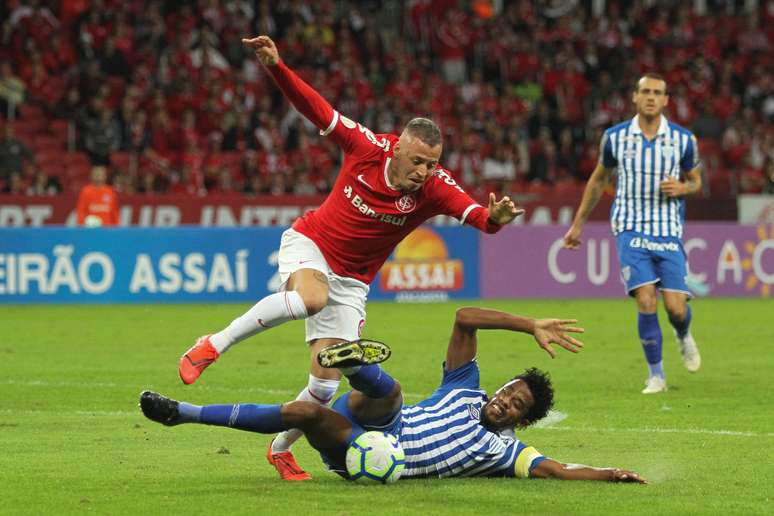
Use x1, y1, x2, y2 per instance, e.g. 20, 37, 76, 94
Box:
379, 227, 464, 292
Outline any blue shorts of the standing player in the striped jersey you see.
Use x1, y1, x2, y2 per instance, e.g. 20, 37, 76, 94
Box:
616, 231, 692, 297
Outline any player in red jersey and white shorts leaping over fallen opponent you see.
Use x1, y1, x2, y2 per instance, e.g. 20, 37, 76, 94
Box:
180, 36, 523, 480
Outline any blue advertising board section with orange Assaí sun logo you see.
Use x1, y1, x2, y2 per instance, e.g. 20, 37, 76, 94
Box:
368, 225, 480, 302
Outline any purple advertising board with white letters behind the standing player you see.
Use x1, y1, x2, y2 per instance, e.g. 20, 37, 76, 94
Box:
481, 222, 774, 298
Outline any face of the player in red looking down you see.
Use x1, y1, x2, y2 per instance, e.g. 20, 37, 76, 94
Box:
388, 134, 443, 192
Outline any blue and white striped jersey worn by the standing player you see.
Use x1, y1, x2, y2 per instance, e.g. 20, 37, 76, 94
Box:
600, 115, 699, 238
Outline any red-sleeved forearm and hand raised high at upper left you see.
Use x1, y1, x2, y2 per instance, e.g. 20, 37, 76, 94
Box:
242, 36, 338, 139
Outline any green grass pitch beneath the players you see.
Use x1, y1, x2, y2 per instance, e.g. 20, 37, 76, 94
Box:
0, 299, 774, 515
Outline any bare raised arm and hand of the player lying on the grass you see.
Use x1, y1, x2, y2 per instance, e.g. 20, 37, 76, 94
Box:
446, 307, 583, 371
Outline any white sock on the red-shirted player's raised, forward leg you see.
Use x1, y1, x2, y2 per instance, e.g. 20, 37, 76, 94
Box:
210, 290, 309, 354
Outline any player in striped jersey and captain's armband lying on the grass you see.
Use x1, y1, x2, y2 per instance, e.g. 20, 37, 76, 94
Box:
140, 308, 645, 483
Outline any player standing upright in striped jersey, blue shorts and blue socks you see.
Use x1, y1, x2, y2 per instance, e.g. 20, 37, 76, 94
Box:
564, 73, 701, 394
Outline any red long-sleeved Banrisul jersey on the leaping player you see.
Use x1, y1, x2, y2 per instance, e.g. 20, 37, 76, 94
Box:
269, 62, 501, 283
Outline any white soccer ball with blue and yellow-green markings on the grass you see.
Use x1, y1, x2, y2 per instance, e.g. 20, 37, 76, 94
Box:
346, 432, 406, 484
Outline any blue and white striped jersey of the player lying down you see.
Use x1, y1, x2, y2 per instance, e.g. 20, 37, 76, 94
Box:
399, 360, 545, 478
